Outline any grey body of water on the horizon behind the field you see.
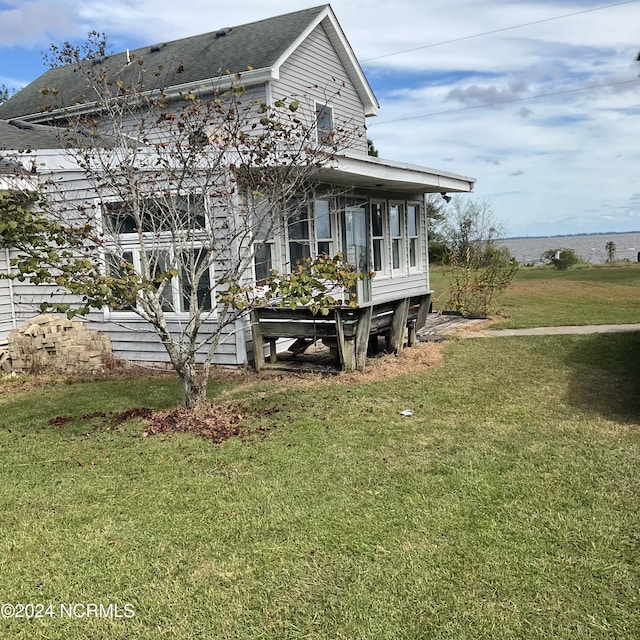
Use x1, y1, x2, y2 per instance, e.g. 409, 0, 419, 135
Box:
500, 232, 640, 265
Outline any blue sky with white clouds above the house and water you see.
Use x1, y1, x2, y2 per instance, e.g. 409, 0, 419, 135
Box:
0, 0, 640, 235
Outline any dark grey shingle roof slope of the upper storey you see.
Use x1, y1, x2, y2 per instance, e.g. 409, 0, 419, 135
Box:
0, 5, 327, 119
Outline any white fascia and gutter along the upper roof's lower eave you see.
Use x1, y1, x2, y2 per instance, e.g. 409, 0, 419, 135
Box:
20, 67, 280, 124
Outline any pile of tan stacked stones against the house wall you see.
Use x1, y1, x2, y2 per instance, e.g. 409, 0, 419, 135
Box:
0, 314, 112, 374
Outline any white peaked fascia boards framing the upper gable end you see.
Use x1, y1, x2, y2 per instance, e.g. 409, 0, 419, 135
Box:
272, 5, 380, 116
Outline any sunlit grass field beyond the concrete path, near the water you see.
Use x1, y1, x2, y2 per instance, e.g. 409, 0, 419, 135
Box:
431, 263, 640, 329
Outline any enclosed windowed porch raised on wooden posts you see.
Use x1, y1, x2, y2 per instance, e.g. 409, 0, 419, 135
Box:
250, 155, 475, 371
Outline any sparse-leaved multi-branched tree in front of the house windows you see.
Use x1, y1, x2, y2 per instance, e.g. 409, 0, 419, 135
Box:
5, 42, 362, 408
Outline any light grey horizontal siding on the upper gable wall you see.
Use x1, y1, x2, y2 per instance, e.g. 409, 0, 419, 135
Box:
272, 25, 367, 155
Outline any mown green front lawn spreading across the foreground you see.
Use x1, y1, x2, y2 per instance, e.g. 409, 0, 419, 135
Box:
0, 333, 640, 640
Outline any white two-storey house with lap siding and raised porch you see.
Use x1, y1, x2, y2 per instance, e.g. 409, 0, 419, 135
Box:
0, 5, 475, 368
